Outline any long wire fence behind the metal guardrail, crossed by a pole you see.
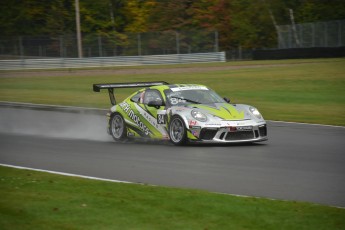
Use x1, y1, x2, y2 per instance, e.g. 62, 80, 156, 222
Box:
0, 30, 218, 59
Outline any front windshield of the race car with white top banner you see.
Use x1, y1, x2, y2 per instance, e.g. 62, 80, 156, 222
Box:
164, 87, 224, 106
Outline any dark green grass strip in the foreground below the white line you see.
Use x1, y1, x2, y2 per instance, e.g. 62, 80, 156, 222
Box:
0, 167, 345, 230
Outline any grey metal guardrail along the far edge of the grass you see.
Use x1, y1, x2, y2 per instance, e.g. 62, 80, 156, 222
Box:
0, 52, 225, 70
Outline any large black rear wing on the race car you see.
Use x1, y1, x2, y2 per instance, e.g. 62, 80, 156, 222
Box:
93, 81, 169, 105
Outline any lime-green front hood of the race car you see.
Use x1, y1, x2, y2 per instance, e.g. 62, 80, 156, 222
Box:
187, 103, 244, 120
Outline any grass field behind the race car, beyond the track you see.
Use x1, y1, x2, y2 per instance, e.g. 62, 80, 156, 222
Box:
0, 58, 345, 126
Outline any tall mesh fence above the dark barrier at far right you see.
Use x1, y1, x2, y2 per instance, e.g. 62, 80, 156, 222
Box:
278, 20, 345, 49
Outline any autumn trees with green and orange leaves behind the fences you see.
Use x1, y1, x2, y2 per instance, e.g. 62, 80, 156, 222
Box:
0, 0, 345, 50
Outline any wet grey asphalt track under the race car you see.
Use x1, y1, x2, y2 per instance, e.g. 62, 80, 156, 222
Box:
0, 107, 345, 207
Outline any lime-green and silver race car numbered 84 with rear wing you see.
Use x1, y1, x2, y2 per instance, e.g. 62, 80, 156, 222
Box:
93, 81, 268, 145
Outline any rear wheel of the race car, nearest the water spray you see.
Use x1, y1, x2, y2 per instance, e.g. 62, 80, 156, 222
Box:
109, 113, 127, 141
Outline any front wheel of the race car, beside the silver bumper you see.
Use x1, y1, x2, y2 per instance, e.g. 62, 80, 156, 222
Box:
169, 115, 187, 145
